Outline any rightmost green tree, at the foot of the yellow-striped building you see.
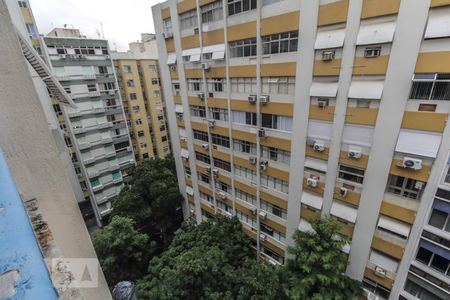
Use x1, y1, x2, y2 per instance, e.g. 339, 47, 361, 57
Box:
287, 218, 362, 300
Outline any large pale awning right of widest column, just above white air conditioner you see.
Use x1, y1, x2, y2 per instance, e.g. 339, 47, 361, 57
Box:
395, 129, 442, 158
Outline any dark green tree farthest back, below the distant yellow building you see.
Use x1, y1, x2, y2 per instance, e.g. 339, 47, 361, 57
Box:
112, 158, 183, 246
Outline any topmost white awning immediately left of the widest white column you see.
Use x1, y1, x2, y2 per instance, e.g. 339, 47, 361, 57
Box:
356, 22, 396, 45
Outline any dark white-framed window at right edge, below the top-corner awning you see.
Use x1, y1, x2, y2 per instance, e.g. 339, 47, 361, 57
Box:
409, 73, 450, 100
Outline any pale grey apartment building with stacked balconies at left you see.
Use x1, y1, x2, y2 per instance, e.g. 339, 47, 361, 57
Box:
42, 28, 135, 225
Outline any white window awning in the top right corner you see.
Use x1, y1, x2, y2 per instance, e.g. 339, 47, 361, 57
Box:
425, 7, 450, 39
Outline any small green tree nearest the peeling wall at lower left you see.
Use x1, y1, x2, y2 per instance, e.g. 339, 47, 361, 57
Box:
92, 216, 153, 286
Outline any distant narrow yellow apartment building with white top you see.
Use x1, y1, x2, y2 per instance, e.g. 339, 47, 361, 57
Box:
111, 34, 170, 161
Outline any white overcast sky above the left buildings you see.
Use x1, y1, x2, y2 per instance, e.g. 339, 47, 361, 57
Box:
30, 0, 163, 51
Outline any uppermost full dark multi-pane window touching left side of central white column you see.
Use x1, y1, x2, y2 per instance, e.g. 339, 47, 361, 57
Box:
262, 31, 298, 54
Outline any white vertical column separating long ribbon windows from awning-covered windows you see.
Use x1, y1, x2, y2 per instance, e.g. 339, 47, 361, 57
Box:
286, 0, 319, 245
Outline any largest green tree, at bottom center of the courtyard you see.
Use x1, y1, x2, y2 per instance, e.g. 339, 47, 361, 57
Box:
137, 218, 282, 300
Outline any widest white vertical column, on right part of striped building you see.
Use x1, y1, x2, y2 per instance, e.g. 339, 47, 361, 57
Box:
347, 1, 429, 280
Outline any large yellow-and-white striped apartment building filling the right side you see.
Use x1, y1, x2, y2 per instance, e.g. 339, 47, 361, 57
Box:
153, 0, 450, 299
